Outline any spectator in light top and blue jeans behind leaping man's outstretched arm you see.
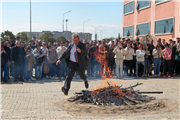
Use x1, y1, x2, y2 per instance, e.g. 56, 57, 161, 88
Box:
56, 42, 67, 80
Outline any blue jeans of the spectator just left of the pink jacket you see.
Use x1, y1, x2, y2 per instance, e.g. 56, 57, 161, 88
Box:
153, 58, 161, 75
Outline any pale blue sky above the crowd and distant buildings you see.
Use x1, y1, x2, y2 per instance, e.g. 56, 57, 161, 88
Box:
0, 0, 123, 39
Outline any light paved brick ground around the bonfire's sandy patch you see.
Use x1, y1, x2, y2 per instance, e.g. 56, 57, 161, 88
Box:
0, 77, 180, 120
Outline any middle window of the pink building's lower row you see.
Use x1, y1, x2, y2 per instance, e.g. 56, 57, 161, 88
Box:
135, 23, 150, 36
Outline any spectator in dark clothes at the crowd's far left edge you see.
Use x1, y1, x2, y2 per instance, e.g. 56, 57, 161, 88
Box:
0, 45, 7, 82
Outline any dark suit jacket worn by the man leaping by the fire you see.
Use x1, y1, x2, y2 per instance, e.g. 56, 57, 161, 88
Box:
60, 42, 87, 67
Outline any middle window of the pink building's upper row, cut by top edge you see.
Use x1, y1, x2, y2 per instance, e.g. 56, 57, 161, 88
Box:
136, 0, 150, 10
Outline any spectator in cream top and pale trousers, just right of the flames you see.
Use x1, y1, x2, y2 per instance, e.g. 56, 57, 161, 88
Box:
113, 42, 125, 78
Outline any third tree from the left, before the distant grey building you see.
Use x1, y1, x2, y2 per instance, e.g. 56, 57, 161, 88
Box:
40, 32, 55, 43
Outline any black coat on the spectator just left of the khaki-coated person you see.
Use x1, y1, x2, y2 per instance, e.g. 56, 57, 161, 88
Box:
11, 46, 26, 64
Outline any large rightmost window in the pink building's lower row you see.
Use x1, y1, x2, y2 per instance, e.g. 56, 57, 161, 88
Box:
155, 18, 174, 34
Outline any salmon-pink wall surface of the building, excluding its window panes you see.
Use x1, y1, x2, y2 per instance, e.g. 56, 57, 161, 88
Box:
123, 0, 180, 41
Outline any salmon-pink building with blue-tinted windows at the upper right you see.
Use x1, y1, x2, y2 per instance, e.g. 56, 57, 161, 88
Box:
123, 0, 180, 41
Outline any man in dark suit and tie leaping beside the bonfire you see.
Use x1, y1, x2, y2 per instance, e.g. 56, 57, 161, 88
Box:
56, 34, 89, 95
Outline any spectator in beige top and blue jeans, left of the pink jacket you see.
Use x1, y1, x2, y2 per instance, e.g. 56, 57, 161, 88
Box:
152, 45, 163, 77
